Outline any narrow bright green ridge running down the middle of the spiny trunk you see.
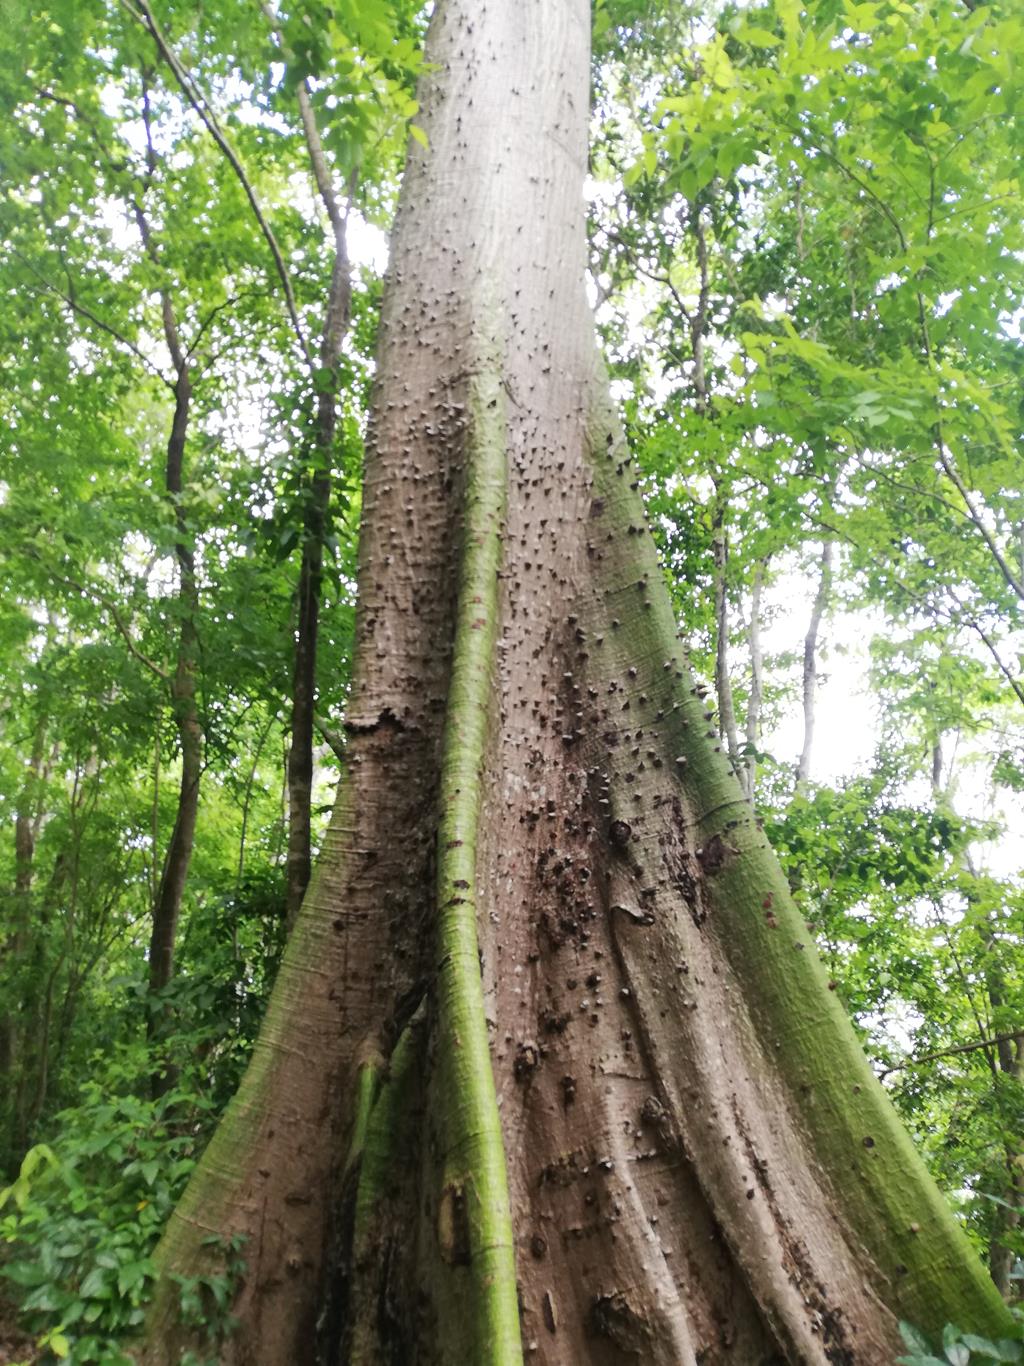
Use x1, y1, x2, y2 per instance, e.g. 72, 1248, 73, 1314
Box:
434, 363, 522, 1366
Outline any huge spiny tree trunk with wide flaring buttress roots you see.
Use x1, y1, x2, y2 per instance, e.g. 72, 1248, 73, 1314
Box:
139, 0, 1021, 1366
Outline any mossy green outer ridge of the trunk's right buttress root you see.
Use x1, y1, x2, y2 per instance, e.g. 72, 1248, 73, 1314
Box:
590, 380, 1010, 1335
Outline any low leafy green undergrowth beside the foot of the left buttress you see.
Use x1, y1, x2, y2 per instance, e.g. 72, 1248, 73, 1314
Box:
0, 1045, 242, 1366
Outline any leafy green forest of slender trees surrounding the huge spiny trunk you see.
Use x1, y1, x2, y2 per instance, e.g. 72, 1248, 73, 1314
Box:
0, 0, 1024, 1366
